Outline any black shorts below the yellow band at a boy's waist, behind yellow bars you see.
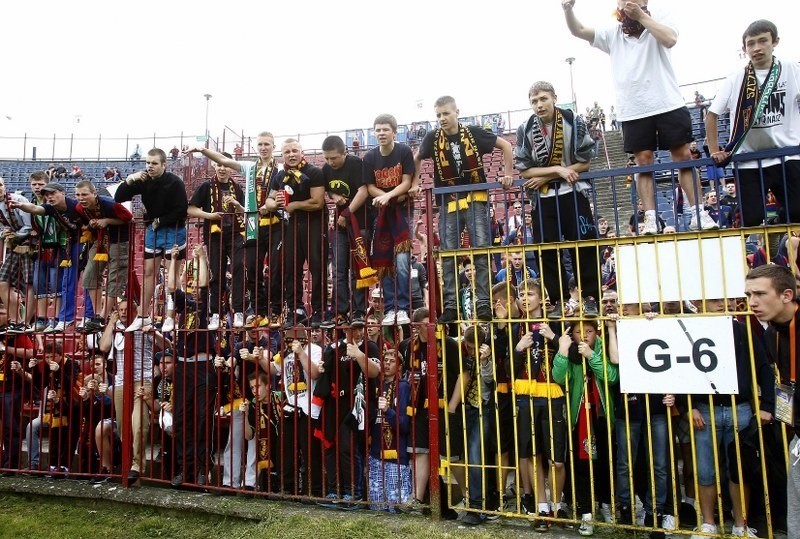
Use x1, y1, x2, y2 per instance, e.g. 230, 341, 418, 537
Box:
517, 396, 567, 462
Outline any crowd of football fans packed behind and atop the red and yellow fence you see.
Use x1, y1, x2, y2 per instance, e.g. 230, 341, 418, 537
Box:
0, 7, 800, 537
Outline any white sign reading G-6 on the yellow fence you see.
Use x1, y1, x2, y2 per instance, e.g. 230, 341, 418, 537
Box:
617, 316, 739, 395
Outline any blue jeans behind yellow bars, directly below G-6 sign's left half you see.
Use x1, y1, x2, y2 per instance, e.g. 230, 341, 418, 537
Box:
616, 415, 668, 515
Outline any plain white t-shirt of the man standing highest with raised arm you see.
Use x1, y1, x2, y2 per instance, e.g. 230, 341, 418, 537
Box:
592, 9, 685, 122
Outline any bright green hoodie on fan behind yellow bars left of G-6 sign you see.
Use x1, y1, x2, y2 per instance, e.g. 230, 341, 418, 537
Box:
553, 336, 619, 428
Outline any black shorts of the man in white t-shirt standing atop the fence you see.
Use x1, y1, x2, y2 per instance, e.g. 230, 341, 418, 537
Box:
622, 107, 694, 153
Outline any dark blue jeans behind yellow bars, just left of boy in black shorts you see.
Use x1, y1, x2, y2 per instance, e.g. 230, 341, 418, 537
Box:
464, 405, 498, 511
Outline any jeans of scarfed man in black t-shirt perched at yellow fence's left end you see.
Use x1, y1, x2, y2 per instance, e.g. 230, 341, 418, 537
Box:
439, 202, 492, 309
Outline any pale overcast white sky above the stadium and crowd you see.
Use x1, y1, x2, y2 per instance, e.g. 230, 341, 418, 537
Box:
0, 0, 800, 157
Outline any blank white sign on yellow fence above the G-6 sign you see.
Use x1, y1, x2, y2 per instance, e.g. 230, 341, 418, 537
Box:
616, 236, 746, 303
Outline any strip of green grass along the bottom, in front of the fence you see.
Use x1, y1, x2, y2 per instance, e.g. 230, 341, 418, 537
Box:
0, 494, 517, 539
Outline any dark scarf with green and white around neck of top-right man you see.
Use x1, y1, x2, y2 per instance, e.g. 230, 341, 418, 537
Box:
718, 58, 781, 167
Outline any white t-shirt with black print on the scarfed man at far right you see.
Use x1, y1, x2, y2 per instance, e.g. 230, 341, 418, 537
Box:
708, 62, 800, 168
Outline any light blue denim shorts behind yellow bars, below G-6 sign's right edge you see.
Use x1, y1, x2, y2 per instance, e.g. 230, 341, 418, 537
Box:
694, 402, 753, 486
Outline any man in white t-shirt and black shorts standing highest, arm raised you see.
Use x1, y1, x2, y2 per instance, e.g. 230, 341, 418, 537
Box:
561, 0, 717, 234
